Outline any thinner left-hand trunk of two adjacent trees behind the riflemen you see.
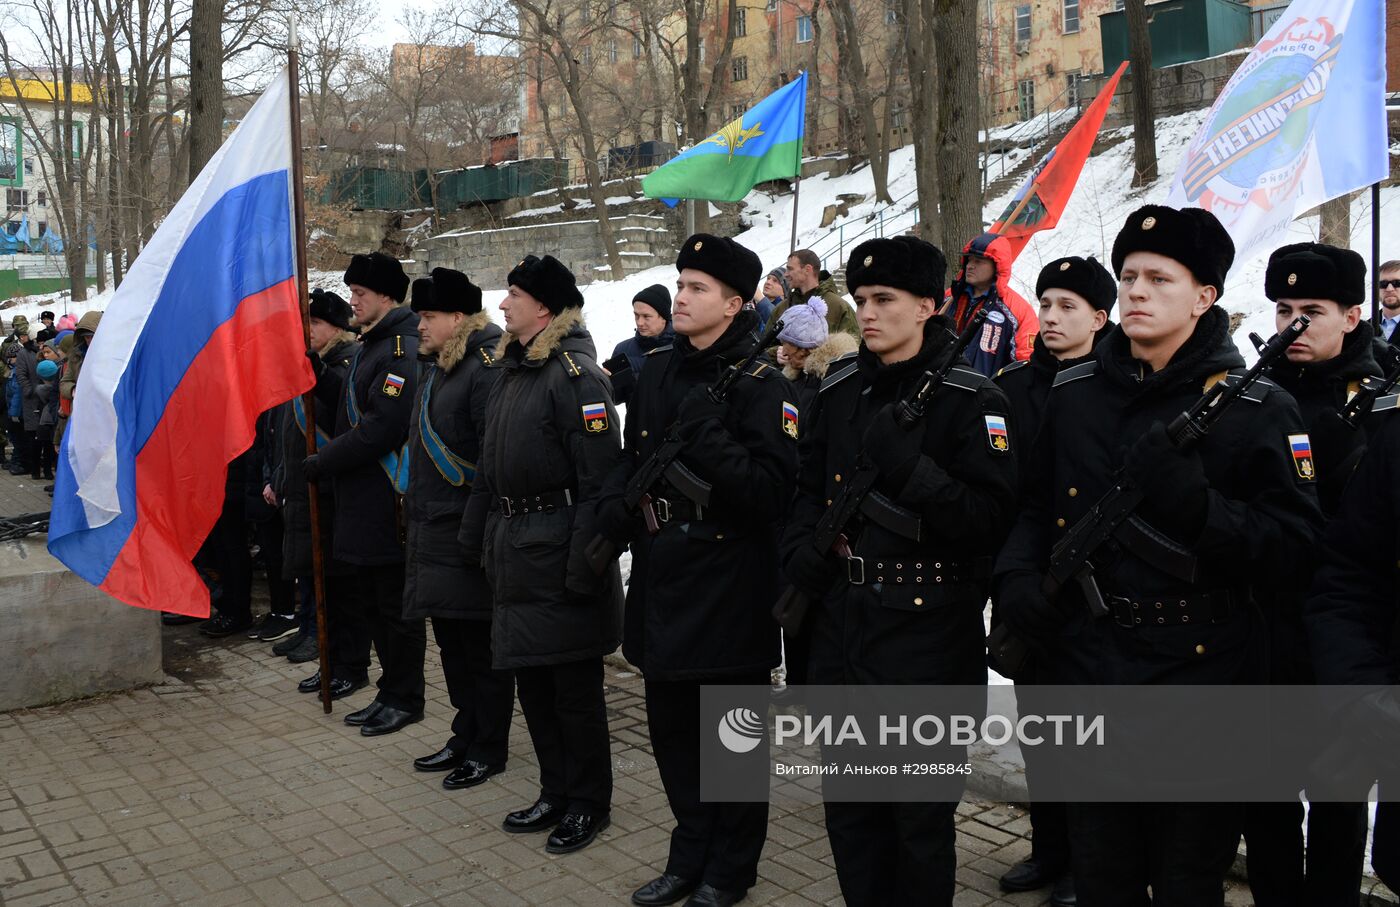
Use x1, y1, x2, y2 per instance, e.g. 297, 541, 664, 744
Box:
902, 0, 940, 248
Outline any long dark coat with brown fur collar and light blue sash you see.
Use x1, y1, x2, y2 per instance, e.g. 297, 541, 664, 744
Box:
403, 312, 501, 620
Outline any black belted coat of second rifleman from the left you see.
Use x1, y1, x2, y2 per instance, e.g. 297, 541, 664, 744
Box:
783, 316, 1016, 684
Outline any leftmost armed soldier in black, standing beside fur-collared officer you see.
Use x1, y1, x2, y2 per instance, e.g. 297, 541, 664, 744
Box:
601, 234, 799, 906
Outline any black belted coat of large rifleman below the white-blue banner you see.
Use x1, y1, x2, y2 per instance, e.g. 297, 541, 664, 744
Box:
997, 307, 1320, 683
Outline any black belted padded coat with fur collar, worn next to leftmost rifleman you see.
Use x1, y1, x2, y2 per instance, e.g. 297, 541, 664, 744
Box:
458, 308, 622, 669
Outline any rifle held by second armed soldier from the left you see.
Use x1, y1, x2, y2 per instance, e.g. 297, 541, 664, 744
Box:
773, 309, 987, 633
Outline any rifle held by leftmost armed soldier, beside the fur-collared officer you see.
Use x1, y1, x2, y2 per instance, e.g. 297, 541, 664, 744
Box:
584, 318, 783, 575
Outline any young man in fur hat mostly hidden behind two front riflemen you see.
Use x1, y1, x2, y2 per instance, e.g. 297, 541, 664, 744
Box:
994, 256, 1119, 907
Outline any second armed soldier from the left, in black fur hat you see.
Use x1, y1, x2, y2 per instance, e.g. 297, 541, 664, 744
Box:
783, 237, 1016, 907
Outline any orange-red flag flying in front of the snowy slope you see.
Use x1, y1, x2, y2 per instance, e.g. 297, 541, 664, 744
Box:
990, 60, 1128, 260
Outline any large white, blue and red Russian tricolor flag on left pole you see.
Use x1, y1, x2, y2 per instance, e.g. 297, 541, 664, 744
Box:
49, 71, 315, 616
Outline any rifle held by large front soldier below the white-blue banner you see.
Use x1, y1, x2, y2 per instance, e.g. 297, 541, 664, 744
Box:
987, 315, 1310, 677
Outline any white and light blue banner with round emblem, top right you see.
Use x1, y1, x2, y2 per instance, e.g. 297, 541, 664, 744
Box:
1166, 0, 1389, 262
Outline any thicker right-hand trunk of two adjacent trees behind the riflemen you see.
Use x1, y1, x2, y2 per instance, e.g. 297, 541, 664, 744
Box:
934, 0, 981, 255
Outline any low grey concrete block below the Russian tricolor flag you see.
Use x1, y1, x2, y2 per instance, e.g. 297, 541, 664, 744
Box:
0, 537, 164, 711
